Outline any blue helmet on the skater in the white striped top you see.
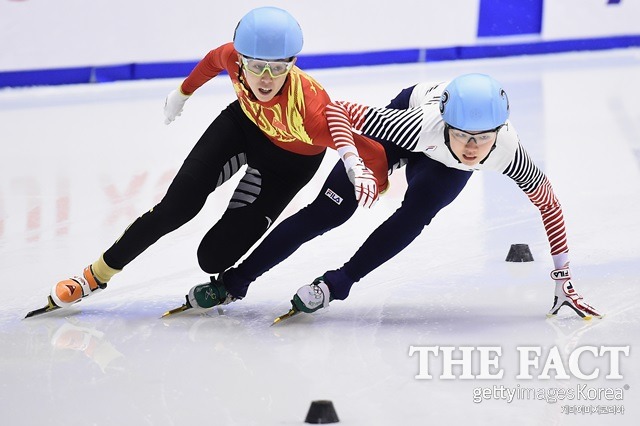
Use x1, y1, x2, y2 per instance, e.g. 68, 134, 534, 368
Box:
440, 74, 509, 131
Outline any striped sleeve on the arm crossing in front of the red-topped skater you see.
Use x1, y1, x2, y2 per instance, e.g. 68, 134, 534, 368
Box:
327, 101, 424, 151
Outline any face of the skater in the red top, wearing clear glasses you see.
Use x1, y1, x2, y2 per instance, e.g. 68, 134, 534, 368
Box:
238, 55, 296, 102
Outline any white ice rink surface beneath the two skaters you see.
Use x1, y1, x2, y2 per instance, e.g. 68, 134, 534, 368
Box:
0, 49, 640, 426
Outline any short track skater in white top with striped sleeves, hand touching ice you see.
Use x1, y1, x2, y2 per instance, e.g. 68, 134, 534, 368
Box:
221, 74, 602, 319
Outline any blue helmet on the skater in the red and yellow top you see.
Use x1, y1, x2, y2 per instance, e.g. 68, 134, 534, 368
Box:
233, 7, 303, 59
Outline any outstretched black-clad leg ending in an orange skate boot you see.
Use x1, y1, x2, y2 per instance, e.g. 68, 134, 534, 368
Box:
51, 102, 252, 306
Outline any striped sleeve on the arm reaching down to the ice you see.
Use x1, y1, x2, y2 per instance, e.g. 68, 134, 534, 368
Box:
503, 144, 569, 255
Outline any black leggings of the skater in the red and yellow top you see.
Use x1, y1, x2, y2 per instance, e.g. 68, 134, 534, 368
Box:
104, 101, 324, 274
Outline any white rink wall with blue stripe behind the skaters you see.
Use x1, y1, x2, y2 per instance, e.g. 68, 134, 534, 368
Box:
0, 0, 640, 87
